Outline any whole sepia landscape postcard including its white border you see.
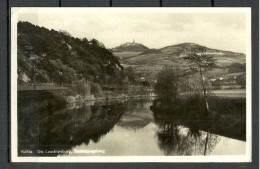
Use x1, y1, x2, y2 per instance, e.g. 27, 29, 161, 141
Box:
11, 8, 252, 162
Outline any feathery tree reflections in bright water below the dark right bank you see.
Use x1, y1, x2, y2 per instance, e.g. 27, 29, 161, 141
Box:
154, 121, 219, 155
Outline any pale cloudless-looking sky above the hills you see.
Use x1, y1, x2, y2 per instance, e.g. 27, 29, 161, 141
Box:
18, 8, 246, 53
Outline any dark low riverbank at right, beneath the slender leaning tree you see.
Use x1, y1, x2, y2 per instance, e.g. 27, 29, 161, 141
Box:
150, 96, 246, 141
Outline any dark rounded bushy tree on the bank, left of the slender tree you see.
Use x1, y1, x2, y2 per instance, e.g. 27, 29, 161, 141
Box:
154, 67, 180, 101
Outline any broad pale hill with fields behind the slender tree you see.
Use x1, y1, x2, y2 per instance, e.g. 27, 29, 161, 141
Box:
115, 43, 246, 84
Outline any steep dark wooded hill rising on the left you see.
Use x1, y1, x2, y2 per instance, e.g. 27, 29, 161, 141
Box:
17, 22, 124, 95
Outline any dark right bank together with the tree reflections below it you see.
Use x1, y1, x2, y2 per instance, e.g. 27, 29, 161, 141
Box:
151, 97, 246, 155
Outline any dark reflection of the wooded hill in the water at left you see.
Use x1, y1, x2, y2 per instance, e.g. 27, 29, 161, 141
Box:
18, 99, 125, 156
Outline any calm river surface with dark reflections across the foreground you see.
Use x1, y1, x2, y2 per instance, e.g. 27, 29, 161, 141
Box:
18, 95, 245, 156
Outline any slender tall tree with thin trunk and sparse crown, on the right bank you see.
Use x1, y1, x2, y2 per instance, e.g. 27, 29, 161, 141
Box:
185, 47, 216, 112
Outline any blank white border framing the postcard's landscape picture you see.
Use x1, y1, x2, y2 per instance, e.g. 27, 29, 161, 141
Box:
11, 7, 252, 162
